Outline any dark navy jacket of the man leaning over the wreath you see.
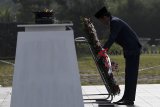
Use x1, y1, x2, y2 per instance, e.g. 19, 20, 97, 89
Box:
103, 17, 142, 54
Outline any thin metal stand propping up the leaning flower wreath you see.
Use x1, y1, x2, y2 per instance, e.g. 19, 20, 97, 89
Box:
75, 37, 114, 107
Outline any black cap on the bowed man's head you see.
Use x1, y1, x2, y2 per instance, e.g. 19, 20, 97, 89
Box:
95, 7, 111, 19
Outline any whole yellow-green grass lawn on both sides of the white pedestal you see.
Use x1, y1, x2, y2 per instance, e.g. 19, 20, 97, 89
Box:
0, 54, 160, 86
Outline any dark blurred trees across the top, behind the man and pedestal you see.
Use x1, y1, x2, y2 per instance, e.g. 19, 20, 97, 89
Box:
0, 0, 160, 38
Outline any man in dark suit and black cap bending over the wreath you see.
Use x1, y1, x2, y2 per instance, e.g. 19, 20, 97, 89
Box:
95, 7, 142, 105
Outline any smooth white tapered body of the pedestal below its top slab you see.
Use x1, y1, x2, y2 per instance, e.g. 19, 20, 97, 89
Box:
11, 24, 84, 107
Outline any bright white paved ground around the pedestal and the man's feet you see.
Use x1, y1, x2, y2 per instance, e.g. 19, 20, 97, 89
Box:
0, 84, 160, 107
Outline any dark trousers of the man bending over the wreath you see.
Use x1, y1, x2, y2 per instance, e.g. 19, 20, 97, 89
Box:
123, 54, 140, 101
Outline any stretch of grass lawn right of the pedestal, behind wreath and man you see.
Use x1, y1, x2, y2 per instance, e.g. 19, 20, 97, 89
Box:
78, 54, 160, 85
